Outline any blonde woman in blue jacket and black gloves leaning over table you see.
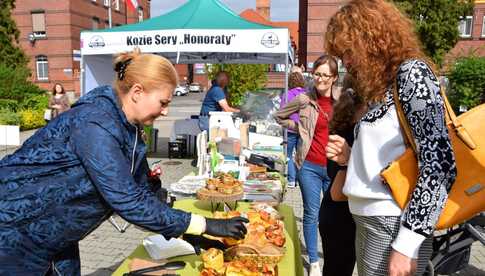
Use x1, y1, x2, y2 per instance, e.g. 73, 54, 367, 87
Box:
0, 49, 248, 276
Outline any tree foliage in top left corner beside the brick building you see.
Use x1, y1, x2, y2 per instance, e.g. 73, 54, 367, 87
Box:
0, 0, 28, 67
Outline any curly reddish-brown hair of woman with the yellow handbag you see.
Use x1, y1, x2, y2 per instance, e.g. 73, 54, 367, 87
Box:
325, 0, 434, 101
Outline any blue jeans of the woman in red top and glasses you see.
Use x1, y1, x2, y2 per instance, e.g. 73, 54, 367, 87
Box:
298, 161, 330, 263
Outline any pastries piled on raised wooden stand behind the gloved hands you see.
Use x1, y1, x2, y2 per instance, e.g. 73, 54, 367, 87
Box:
197, 173, 244, 202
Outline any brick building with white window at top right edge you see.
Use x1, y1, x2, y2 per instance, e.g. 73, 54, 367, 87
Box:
448, 0, 485, 61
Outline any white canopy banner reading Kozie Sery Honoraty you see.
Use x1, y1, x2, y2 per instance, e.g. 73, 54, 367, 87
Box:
81, 29, 289, 55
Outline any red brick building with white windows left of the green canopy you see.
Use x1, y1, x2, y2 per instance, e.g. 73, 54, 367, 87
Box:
12, 0, 150, 95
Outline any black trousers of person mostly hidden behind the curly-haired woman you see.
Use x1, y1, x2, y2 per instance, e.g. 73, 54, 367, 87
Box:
319, 197, 355, 276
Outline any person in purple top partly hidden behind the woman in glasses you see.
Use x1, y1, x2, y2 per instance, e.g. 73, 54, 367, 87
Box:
281, 71, 306, 188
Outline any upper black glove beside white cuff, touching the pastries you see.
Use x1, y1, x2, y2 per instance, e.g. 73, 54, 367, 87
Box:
205, 217, 249, 240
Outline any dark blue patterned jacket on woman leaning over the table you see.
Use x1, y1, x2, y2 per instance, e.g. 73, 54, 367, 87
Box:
0, 86, 190, 275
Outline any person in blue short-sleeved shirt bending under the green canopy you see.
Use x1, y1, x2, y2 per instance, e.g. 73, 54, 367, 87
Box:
199, 71, 239, 133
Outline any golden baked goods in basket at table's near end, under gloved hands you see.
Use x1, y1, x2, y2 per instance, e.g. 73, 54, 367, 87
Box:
201, 203, 286, 276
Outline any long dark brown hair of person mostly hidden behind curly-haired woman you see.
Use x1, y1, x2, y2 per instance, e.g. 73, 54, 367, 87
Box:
329, 74, 365, 134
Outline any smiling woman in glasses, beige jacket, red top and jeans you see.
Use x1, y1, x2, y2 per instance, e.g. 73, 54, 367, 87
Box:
275, 55, 338, 276
